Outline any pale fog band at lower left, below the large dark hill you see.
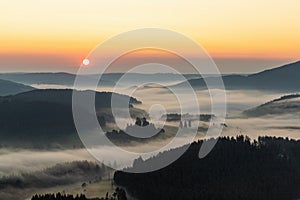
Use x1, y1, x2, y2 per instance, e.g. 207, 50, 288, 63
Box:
0, 136, 198, 179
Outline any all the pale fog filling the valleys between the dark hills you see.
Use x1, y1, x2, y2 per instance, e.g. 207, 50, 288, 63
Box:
0, 79, 300, 191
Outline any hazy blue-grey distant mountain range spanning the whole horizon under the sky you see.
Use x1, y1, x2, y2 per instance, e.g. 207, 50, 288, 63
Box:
0, 61, 300, 92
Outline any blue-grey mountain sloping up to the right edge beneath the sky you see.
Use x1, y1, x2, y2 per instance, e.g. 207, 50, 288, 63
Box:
173, 61, 300, 92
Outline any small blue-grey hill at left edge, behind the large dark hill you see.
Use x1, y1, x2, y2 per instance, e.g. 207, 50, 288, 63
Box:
0, 79, 35, 96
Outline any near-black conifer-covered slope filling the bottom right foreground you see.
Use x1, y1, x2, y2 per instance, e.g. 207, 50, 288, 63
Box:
114, 136, 300, 200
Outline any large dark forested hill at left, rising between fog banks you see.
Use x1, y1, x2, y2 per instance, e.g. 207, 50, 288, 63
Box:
0, 89, 140, 148
